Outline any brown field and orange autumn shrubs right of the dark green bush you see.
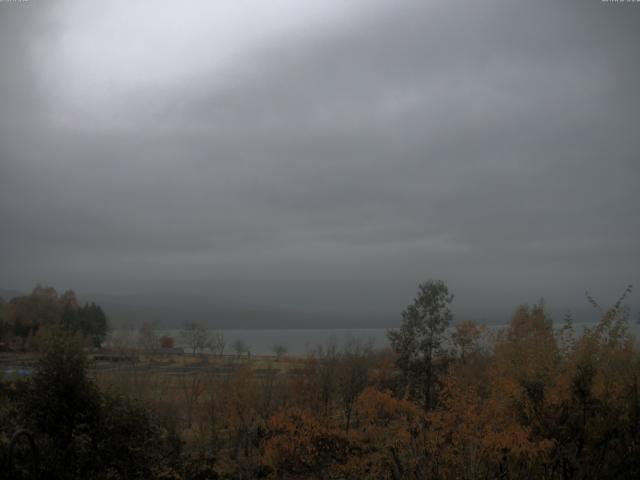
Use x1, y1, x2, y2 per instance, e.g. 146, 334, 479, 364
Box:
1, 284, 640, 480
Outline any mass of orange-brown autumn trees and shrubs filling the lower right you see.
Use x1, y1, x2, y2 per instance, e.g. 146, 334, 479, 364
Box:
263, 284, 640, 480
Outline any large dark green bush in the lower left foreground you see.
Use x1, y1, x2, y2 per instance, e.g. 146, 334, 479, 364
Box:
2, 332, 180, 480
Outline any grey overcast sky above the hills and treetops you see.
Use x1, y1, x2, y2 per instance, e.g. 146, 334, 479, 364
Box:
0, 0, 640, 322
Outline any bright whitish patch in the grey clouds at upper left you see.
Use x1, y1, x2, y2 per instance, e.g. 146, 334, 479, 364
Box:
34, 0, 376, 120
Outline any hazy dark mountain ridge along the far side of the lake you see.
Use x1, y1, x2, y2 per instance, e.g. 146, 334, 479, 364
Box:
0, 288, 624, 330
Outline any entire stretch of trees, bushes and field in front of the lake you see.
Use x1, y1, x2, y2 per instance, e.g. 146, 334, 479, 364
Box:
0, 281, 640, 480
